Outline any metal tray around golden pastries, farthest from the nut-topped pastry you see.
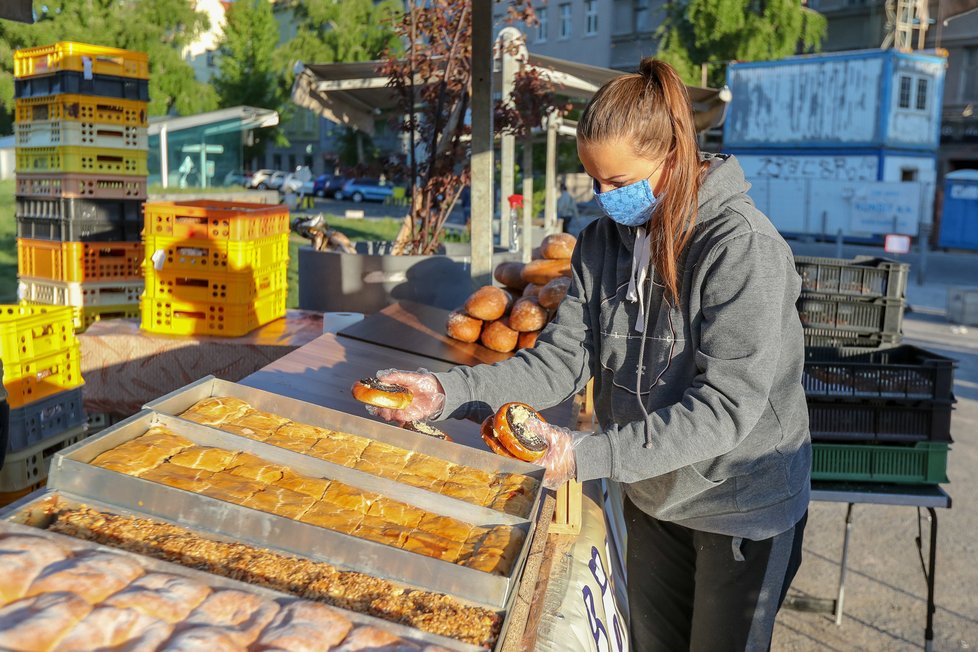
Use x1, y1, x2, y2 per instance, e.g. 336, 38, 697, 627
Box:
143, 376, 544, 486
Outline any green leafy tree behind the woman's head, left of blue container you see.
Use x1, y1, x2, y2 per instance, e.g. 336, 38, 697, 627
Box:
658, 0, 827, 86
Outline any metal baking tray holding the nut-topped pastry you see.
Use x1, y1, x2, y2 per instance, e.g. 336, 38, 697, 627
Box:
0, 489, 484, 652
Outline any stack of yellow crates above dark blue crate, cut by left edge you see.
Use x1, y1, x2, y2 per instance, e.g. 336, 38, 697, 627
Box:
0, 304, 86, 505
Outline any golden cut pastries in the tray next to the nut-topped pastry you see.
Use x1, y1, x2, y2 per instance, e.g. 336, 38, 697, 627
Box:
92, 426, 525, 575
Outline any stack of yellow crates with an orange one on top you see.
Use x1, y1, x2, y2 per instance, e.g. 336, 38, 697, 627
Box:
141, 200, 289, 337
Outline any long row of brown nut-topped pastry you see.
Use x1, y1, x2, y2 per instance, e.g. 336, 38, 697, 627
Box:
51, 507, 501, 646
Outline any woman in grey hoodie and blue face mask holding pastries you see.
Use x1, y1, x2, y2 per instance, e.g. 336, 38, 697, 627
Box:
370, 59, 811, 652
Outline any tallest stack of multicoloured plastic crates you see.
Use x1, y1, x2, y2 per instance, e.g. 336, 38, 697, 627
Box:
14, 42, 149, 331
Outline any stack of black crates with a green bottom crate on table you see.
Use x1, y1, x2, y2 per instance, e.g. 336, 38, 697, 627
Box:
795, 256, 955, 484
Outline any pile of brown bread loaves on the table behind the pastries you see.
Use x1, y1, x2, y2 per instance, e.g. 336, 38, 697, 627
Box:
446, 233, 577, 353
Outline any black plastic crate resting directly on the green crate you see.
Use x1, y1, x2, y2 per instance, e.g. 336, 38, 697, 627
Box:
808, 399, 952, 442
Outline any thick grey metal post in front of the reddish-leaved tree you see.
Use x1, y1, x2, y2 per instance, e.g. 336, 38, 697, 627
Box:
471, 0, 493, 285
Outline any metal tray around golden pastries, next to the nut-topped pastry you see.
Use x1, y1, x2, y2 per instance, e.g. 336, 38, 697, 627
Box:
48, 410, 536, 610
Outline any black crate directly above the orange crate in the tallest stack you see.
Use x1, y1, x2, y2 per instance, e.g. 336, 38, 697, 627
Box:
16, 197, 143, 242
